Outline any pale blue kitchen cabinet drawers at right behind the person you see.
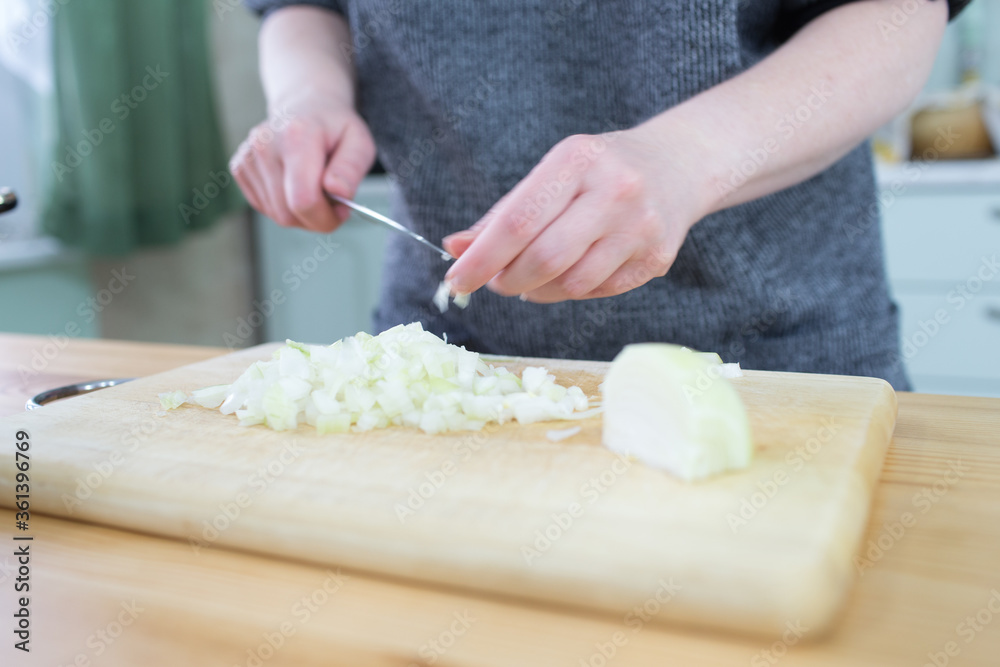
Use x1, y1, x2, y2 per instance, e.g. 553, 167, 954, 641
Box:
878, 161, 1000, 396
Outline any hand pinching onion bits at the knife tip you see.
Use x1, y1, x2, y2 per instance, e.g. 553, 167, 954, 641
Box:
444, 126, 710, 303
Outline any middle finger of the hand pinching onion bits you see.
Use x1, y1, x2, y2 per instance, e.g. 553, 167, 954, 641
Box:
488, 190, 617, 296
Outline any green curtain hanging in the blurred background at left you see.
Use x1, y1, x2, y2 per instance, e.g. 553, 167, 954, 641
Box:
42, 0, 242, 255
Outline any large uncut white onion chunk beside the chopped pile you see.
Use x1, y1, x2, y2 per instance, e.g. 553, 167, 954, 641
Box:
603, 343, 753, 481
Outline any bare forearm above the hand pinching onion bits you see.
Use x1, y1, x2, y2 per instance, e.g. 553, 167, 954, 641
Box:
637, 0, 947, 215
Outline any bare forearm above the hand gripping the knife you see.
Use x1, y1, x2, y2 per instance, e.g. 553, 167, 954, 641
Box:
259, 5, 354, 113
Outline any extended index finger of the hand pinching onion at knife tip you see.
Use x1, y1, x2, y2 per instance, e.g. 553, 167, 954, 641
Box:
447, 140, 580, 293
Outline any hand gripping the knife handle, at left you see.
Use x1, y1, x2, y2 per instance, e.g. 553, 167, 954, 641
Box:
229, 99, 375, 232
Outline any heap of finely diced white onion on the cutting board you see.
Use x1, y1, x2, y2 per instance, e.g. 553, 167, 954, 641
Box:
178, 323, 600, 433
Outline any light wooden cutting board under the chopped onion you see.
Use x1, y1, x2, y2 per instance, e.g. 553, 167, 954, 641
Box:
0, 344, 896, 637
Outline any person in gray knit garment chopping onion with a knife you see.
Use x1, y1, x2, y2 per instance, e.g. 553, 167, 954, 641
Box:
231, 0, 968, 389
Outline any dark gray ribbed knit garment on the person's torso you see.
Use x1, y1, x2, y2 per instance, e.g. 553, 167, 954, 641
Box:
248, 0, 965, 389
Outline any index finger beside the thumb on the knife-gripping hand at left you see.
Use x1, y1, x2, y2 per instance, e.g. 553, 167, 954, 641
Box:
282, 127, 341, 232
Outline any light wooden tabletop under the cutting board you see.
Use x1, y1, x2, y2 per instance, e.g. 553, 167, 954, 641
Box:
0, 334, 1000, 667
